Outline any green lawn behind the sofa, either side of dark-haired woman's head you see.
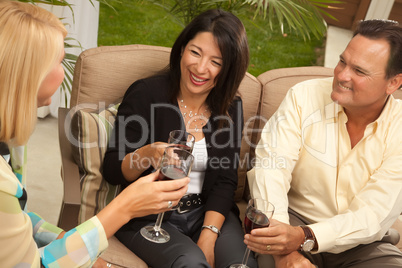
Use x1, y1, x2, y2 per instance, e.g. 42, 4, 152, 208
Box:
98, 0, 325, 76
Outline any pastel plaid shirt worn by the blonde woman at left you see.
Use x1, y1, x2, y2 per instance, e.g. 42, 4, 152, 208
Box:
0, 154, 108, 267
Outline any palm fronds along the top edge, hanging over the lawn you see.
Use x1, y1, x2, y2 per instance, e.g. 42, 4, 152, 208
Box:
142, 0, 343, 40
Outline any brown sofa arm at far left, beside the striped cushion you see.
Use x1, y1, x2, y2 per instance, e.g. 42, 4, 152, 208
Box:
57, 108, 81, 231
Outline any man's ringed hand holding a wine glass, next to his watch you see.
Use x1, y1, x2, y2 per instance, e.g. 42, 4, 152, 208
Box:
244, 219, 304, 255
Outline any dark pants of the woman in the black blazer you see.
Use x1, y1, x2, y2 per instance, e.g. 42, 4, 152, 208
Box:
115, 207, 257, 268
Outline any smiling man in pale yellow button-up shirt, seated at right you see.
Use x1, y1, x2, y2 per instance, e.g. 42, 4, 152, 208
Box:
246, 20, 402, 268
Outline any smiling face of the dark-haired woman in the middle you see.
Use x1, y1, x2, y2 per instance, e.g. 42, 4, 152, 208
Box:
180, 32, 222, 97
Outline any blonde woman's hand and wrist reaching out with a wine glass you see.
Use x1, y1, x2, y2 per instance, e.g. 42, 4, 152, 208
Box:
97, 171, 190, 238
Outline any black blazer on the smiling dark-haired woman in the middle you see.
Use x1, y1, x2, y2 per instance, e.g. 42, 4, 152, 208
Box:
103, 75, 243, 220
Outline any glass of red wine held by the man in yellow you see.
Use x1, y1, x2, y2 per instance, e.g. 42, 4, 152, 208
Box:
229, 198, 275, 268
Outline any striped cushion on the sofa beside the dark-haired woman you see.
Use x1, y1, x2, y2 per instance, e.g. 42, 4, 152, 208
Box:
71, 104, 120, 222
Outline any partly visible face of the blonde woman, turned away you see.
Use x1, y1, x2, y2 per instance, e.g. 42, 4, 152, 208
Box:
38, 39, 65, 107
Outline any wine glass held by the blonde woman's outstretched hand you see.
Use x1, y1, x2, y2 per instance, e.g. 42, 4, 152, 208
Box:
140, 146, 194, 243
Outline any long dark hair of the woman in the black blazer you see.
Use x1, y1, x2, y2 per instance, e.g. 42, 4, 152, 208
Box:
169, 9, 249, 123
